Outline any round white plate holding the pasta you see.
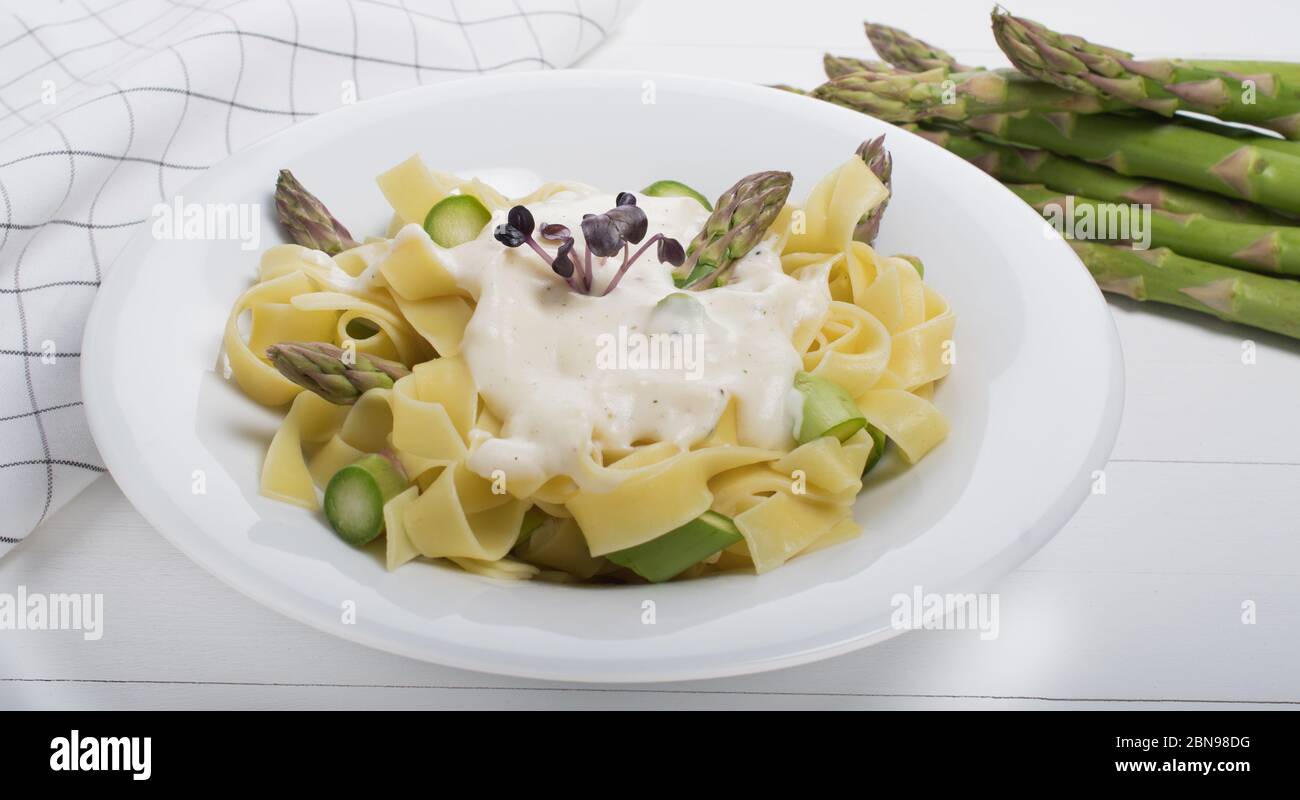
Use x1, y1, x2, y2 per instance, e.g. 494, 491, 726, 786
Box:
83, 72, 1123, 682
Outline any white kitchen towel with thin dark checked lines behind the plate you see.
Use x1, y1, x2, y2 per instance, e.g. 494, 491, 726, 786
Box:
0, 0, 632, 553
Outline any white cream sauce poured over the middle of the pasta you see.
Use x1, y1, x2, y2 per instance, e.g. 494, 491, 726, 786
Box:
410, 190, 829, 490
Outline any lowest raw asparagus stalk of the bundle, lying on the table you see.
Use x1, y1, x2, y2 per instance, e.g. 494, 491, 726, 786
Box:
1070, 242, 1300, 338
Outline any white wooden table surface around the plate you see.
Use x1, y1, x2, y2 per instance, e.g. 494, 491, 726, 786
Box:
0, 0, 1300, 709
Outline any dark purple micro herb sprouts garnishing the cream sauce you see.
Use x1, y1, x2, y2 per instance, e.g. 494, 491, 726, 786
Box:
493, 191, 686, 297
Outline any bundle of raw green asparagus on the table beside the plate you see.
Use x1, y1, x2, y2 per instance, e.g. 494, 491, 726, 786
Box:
787, 9, 1300, 338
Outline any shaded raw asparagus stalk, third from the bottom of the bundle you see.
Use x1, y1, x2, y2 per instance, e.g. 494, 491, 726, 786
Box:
914, 129, 1282, 224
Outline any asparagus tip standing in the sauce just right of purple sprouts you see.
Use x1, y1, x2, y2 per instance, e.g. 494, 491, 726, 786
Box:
680, 172, 794, 289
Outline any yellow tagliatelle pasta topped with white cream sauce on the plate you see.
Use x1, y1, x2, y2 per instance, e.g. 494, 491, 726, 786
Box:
224, 156, 956, 581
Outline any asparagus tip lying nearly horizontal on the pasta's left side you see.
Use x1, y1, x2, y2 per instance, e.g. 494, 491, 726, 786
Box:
267, 342, 411, 406
